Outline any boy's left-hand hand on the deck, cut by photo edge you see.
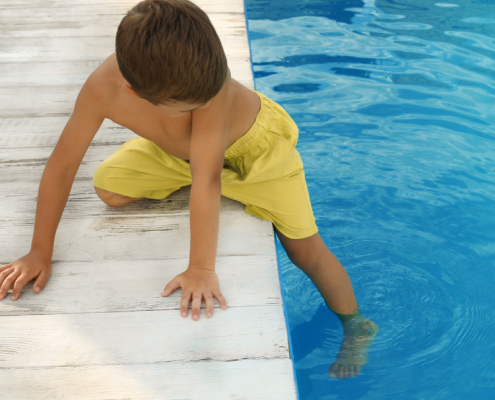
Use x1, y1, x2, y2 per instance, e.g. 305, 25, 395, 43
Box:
0, 252, 52, 300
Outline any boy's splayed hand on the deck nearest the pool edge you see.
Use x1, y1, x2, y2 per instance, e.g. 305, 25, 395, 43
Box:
161, 266, 227, 321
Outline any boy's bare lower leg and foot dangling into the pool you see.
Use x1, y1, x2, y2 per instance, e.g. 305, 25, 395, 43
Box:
275, 228, 378, 379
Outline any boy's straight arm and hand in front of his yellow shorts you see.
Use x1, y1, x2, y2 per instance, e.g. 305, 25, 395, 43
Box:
163, 71, 233, 319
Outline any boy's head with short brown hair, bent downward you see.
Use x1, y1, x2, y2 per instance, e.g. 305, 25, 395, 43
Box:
115, 0, 228, 105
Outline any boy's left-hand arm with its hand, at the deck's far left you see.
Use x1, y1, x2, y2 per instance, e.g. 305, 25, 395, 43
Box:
0, 76, 105, 300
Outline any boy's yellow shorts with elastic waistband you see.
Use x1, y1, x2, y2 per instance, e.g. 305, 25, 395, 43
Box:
93, 91, 318, 239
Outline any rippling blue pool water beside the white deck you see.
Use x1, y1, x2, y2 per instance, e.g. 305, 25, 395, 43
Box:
246, 0, 495, 400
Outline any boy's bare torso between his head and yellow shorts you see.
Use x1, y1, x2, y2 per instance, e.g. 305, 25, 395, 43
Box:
94, 53, 261, 160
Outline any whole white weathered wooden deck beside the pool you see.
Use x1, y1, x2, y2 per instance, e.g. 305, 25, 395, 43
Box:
0, 0, 296, 400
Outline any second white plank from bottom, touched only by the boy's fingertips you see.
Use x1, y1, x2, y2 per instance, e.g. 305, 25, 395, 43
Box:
0, 305, 289, 368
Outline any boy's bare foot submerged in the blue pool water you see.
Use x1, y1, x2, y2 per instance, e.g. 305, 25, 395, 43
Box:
328, 317, 378, 379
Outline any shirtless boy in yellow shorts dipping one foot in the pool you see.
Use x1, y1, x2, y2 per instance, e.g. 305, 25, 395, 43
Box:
0, 0, 378, 379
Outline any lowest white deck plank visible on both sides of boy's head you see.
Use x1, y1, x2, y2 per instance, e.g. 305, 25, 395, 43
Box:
0, 54, 254, 88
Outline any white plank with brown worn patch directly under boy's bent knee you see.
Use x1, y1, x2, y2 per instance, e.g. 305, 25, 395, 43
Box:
0, 180, 244, 221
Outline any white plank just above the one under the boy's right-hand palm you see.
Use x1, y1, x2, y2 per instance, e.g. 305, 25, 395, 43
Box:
0, 213, 275, 265
